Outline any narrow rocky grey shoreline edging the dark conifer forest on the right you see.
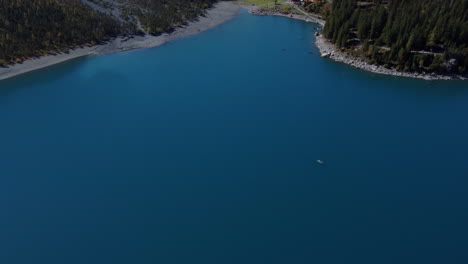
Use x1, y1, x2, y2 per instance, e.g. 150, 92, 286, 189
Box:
247, 5, 468, 81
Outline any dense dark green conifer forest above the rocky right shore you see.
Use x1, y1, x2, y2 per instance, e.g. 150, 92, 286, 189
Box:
323, 0, 468, 74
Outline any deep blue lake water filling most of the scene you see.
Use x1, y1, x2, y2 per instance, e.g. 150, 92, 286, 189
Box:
0, 11, 468, 264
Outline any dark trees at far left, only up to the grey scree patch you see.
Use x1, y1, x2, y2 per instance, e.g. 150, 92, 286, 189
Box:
0, 0, 121, 65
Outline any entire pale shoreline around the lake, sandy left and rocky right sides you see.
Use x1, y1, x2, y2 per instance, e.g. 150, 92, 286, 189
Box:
0, 1, 468, 81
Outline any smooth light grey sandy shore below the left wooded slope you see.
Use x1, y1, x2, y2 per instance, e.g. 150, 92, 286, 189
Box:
0, 2, 240, 80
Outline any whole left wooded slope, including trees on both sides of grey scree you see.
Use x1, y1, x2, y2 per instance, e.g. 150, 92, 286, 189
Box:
0, 0, 215, 66
